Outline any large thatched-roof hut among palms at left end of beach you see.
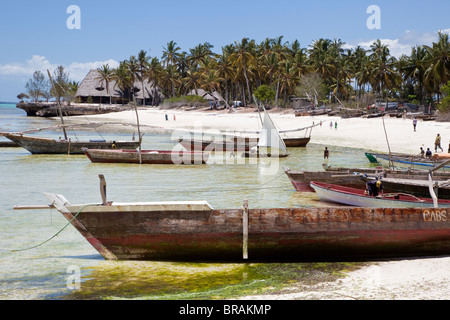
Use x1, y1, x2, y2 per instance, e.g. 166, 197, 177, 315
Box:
76, 69, 164, 105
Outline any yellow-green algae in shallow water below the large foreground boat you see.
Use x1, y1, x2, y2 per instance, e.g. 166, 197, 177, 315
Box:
63, 261, 362, 300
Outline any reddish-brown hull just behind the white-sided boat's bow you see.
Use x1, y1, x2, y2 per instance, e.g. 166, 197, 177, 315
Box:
284, 167, 366, 192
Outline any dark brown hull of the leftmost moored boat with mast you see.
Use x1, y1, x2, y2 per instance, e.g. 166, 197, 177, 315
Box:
4, 134, 139, 154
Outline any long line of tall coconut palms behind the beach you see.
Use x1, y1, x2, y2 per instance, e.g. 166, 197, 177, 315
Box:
19, 32, 450, 110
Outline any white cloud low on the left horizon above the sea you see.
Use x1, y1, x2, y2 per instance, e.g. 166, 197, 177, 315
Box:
0, 55, 119, 81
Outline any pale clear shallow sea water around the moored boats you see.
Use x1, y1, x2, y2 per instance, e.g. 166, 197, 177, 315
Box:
0, 103, 368, 299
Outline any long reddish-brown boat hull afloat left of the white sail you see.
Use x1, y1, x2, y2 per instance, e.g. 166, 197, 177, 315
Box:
84, 149, 209, 165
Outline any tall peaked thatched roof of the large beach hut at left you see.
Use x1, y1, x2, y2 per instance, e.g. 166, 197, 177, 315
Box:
76, 69, 162, 99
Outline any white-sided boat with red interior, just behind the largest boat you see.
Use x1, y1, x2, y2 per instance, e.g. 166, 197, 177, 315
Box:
311, 181, 450, 208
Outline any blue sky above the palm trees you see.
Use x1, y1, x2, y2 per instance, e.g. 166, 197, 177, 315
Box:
0, 0, 450, 102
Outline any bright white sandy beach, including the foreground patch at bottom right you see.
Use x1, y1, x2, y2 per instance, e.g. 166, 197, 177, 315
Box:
72, 108, 450, 300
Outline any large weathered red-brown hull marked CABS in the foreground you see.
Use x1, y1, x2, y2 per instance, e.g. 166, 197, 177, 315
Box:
49, 192, 450, 261
